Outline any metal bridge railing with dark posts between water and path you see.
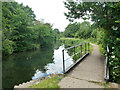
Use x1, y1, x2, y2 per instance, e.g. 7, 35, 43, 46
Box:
62, 43, 90, 73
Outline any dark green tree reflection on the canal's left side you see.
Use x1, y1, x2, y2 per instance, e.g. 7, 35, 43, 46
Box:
2, 48, 54, 88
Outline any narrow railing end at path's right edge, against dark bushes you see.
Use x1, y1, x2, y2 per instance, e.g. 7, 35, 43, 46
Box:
104, 45, 109, 82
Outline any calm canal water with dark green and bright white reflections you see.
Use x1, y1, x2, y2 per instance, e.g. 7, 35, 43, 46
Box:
2, 44, 73, 88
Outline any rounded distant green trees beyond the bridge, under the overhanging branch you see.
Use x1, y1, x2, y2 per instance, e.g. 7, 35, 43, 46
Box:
64, 21, 92, 39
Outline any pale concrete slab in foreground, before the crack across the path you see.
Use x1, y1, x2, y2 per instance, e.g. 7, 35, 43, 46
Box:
59, 77, 104, 88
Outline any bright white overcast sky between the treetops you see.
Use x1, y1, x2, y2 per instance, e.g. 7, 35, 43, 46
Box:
15, 0, 92, 31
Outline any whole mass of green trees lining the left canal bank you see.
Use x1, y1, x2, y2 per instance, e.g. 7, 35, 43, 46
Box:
2, 2, 55, 55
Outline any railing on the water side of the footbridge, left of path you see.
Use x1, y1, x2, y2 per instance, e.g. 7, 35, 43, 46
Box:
62, 43, 89, 73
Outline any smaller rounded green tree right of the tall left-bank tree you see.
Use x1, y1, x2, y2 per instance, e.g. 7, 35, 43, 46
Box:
34, 21, 54, 47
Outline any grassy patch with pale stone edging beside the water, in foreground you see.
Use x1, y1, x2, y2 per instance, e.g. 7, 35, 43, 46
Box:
14, 74, 64, 88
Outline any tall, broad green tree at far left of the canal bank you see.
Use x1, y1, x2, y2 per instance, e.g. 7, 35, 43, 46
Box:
2, 2, 35, 54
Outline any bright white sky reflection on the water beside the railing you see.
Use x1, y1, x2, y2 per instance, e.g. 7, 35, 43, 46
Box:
32, 45, 73, 79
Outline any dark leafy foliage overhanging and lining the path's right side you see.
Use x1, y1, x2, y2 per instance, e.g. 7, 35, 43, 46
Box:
64, 0, 120, 83
